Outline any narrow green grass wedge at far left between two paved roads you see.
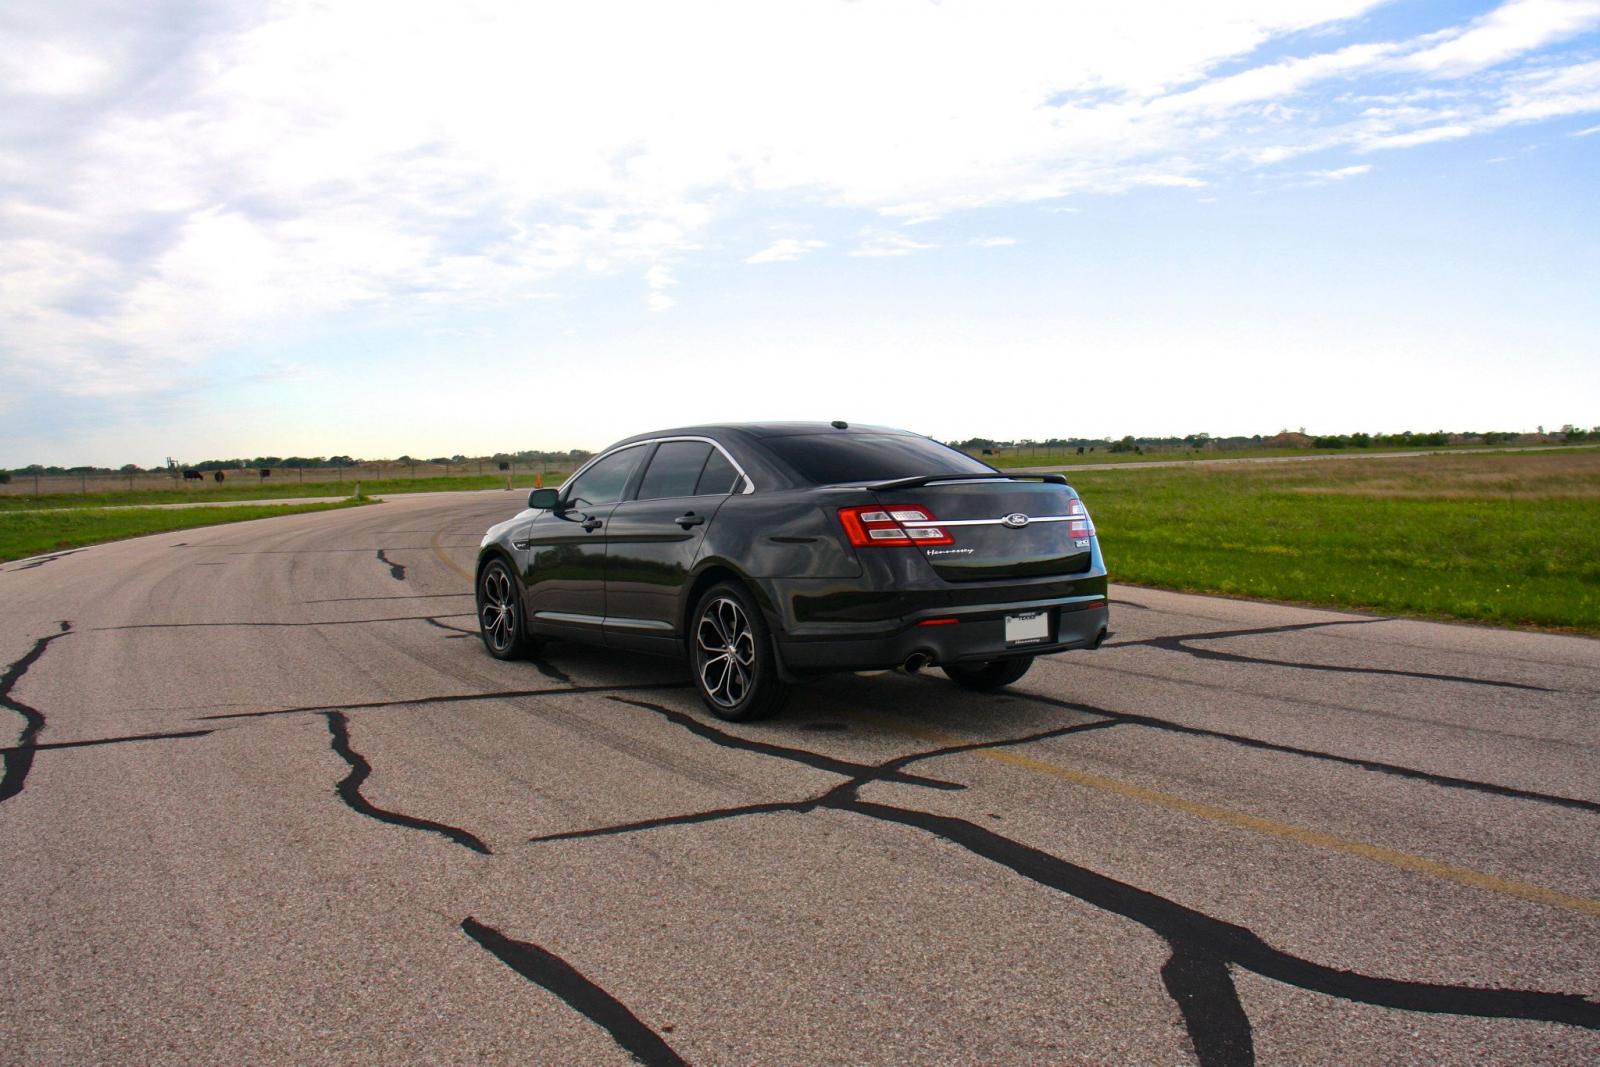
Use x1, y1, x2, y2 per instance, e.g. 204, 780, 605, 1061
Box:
0, 502, 365, 561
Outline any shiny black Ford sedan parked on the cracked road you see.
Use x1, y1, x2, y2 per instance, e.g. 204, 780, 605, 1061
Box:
477, 422, 1109, 720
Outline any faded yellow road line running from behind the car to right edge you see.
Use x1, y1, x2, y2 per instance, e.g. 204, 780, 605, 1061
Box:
846, 712, 1600, 915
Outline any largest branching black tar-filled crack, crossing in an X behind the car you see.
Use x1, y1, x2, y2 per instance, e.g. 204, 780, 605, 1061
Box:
518, 697, 1600, 1067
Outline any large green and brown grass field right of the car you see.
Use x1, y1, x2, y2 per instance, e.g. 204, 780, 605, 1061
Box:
1070, 451, 1600, 633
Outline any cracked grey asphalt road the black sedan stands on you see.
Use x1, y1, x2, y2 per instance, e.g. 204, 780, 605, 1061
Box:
0, 493, 1600, 1064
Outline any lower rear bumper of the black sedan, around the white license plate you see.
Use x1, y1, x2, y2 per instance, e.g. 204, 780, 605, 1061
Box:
778, 593, 1110, 673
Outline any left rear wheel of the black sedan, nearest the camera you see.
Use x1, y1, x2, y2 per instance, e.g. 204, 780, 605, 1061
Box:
688, 582, 789, 723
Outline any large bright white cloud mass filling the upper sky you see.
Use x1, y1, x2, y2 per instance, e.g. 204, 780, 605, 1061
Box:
0, 0, 1600, 399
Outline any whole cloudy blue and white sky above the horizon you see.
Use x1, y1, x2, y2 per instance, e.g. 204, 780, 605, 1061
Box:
0, 0, 1600, 466
